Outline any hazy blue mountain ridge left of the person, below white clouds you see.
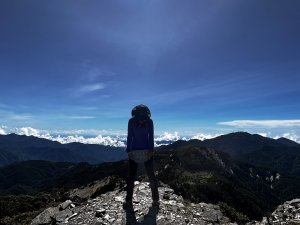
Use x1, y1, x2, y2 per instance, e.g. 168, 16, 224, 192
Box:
0, 134, 126, 166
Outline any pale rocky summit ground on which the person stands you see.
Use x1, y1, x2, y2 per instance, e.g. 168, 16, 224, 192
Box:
31, 181, 236, 225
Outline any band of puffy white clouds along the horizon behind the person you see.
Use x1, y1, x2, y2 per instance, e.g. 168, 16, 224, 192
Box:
0, 126, 300, 147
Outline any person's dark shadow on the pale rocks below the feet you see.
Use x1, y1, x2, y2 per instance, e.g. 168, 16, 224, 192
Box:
126, 206, 159, 225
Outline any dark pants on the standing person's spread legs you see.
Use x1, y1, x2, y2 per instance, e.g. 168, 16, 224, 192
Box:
126, 157, 159, 201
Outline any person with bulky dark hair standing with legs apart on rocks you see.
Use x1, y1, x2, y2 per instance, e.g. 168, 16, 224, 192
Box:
124, 105, 159, 209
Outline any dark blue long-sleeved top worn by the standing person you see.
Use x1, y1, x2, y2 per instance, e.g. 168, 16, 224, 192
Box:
126, 118, 154, 152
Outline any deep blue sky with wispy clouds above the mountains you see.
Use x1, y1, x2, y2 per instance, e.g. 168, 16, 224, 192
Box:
0, 0, 300, 140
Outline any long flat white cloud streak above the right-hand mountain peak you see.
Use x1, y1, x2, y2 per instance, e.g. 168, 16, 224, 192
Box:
218, 120, 300, 128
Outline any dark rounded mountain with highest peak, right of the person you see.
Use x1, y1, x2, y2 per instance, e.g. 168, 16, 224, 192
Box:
160, 132, 300, 178
